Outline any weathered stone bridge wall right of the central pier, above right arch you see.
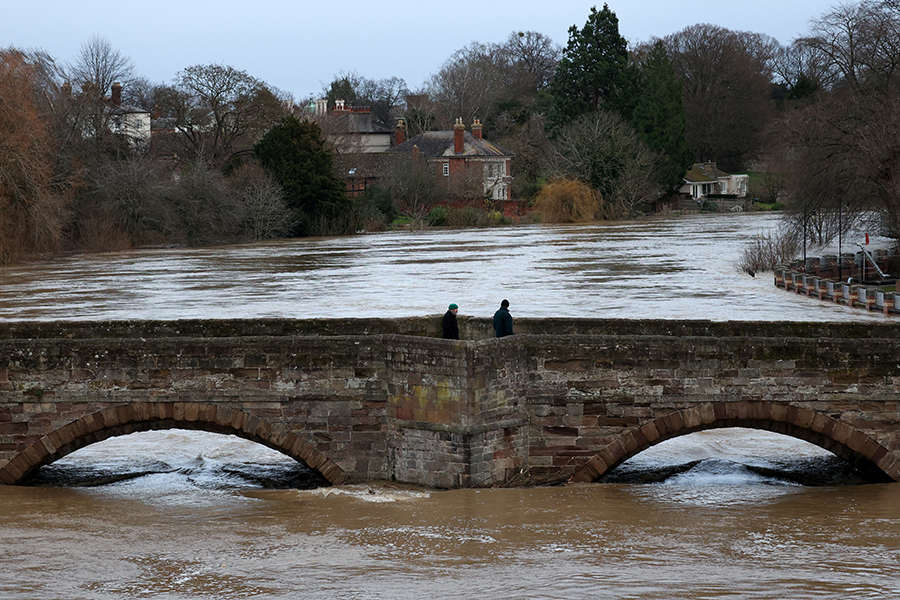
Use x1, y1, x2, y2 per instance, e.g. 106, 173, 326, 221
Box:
526, 330, 900, 479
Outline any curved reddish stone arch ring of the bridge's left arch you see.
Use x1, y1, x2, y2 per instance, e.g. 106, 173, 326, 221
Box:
0, 402, 348, 485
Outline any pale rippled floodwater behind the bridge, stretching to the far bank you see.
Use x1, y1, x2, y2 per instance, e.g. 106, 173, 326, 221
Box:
0, 214, 879, 321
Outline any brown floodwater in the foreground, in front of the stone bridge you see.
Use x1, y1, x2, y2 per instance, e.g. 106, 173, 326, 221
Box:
0, 464, 900, 600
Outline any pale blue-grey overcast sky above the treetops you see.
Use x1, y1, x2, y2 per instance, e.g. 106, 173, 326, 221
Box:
0, 0, 836, 99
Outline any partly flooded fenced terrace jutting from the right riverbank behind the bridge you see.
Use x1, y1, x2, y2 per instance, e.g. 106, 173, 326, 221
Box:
775, 250, 900, 315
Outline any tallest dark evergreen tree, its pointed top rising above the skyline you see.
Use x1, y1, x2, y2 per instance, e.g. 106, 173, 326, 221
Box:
550, 4, 628, 129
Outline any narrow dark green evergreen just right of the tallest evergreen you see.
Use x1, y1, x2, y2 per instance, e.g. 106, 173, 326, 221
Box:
620, 41, 694, 188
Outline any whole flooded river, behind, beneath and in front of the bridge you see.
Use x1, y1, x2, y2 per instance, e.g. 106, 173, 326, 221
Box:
0, 215, 900, 600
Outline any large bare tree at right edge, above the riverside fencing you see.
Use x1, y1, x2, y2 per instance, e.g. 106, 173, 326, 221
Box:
778, 0, 900, 242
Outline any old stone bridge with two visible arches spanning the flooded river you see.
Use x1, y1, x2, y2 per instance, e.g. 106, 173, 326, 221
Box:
0, 316, 900, 488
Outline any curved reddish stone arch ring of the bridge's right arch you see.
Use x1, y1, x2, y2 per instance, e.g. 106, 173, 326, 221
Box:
570, 402, 900, 482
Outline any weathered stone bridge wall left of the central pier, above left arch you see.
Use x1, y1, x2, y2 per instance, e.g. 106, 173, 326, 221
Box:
0, 326, 391, 486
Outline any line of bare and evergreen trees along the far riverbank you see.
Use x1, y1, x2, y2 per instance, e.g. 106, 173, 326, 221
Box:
0, 0, 900, 263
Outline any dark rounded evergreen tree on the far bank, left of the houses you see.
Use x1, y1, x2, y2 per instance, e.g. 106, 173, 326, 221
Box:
254, 116, 355, 235
